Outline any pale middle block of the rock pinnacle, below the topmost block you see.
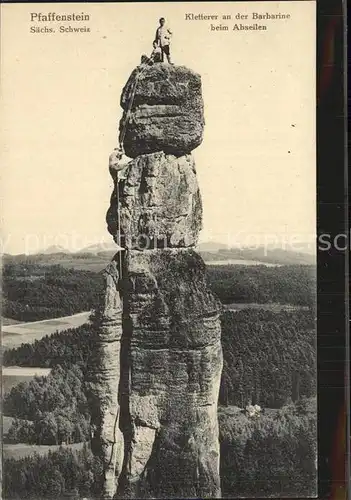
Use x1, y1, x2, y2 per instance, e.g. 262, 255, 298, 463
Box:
106, 152, 202, 249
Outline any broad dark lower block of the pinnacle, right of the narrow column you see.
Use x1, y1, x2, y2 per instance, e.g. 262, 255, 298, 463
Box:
120, 249, 222, 498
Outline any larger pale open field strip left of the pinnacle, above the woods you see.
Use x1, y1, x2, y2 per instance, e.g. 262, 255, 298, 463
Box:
2, 311, 91, 350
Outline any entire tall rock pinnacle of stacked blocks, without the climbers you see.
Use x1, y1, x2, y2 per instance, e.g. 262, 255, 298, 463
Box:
93, 63, 222, 498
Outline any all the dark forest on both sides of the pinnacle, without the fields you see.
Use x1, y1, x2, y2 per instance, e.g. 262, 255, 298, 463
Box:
3, 261, 316, 500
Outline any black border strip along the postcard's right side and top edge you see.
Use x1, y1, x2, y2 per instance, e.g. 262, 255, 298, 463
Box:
1, 0, 351, 500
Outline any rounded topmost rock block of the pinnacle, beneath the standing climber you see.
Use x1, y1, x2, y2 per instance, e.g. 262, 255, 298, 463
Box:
120, 63, 204, 158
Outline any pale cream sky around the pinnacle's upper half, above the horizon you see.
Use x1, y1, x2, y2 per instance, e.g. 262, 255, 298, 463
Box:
0, 1, 316, 253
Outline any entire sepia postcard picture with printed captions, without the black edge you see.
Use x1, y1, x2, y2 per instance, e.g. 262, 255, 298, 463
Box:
0, 0, 320, 500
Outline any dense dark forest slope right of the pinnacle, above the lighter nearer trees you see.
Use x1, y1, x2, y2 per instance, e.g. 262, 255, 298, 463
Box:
219, 309, 317, 408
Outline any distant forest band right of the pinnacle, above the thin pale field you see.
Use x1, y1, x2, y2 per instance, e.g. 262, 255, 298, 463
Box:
207, 265, 316, 308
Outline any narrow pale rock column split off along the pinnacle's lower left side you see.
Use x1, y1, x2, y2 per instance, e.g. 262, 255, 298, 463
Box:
89, 257, 124, 498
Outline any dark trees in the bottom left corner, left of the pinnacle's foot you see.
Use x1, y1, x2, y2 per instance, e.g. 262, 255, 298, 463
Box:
2, 446, 102, 500
